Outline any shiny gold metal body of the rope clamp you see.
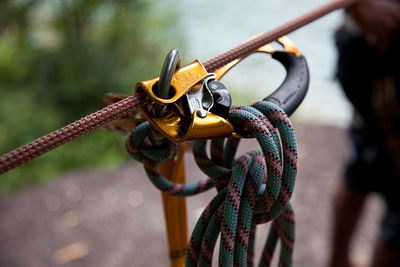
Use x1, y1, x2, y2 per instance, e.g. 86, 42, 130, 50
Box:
135, 60, 233, 143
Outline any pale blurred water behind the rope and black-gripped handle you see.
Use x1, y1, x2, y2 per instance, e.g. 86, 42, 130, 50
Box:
179, 0, 352, 127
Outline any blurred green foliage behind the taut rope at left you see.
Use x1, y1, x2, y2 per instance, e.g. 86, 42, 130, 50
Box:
0, 0, 182, 193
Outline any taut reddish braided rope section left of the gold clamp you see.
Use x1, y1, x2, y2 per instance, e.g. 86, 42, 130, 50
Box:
0, 96, 141, 175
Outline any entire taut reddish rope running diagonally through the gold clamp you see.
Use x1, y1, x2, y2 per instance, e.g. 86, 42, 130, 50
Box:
0, 0, 358, 175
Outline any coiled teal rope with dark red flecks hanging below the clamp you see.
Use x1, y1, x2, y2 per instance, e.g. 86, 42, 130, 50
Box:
126, 101, 297, 266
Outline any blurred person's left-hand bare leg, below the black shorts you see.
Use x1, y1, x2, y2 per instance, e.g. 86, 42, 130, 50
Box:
328, 184, 367, 267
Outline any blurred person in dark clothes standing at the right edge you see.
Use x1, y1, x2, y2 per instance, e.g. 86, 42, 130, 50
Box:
328, 0, 400, 267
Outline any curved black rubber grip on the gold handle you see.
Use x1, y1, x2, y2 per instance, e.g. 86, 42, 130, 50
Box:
264, 51, 310, 116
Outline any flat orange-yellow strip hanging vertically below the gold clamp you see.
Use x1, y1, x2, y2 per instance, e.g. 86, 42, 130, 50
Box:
158, 144, 188, 267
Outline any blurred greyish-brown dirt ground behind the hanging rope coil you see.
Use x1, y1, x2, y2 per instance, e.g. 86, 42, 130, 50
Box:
0, 126, 382, 267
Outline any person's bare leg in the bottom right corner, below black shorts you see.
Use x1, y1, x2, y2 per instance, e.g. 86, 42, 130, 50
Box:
371, 240, 400, 267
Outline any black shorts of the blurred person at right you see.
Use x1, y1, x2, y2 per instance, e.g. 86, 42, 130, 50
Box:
344, 122, 400, 252
